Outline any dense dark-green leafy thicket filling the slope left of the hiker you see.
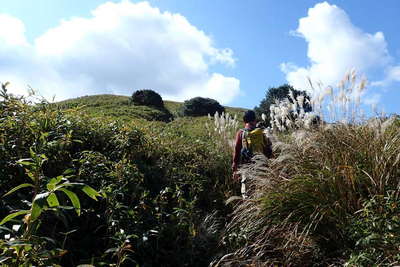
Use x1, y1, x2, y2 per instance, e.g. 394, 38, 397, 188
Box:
0, 84, 232, 266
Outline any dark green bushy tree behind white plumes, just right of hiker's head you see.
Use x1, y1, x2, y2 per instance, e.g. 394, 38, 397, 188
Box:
254, 84, 312, 124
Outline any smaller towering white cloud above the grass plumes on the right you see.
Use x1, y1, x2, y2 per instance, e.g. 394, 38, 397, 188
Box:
281, 2, 390, 92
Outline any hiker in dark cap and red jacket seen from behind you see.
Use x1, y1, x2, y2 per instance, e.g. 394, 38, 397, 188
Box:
232, 110, 272, 179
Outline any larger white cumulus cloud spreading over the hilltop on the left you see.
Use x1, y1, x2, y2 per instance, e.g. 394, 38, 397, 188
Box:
0, 1, 240, 103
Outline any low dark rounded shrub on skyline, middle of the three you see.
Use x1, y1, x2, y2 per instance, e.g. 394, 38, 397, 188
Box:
182, 97, 225, 116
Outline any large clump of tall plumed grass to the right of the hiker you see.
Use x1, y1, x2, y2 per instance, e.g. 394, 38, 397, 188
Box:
219, 72, 400, 266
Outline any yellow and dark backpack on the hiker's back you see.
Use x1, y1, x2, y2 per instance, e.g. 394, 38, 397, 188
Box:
240, 128, 266, 162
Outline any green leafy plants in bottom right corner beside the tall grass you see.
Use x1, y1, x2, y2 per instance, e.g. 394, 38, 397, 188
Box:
346, 191, 400, 266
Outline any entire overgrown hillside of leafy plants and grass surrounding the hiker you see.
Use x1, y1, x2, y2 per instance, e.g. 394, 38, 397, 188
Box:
4, 84, 400, 266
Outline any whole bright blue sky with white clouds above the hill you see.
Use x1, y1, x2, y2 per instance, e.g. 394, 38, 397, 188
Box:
0, 0, 400, 113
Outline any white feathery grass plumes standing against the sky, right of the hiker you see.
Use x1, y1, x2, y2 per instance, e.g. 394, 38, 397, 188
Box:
270, 70, 367, 132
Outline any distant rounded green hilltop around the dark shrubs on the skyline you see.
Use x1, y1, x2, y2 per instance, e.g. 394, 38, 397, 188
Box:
57, 95, 244, 121
